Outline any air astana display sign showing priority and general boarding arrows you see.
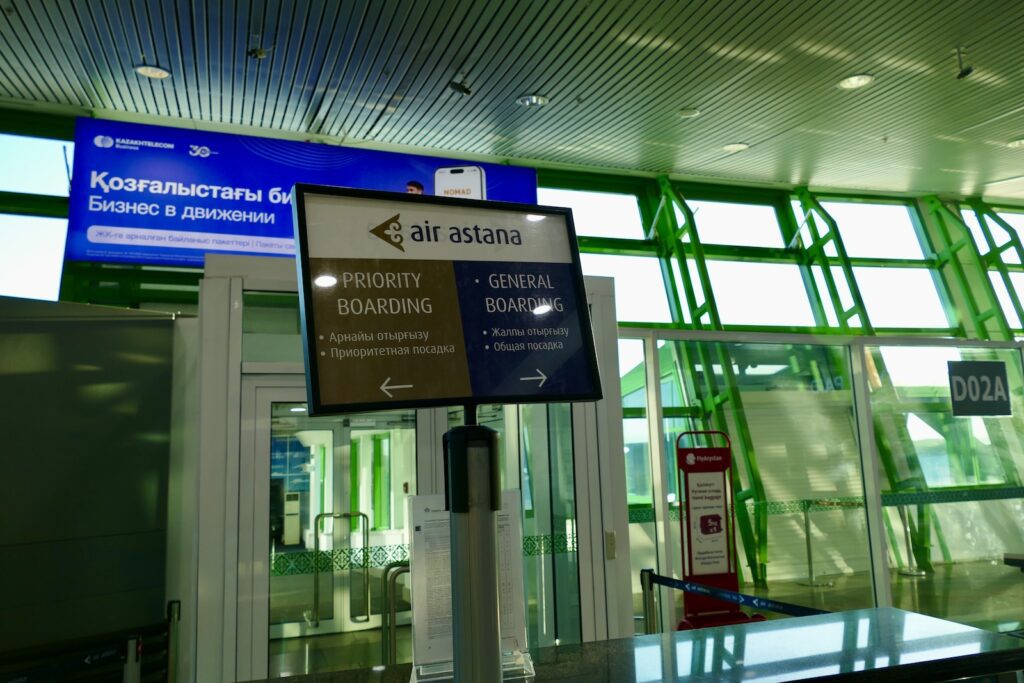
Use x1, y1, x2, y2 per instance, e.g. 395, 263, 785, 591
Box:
294, 184, 601, 415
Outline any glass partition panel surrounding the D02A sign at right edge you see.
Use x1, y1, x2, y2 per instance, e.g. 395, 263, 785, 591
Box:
865, 345, 1024, 631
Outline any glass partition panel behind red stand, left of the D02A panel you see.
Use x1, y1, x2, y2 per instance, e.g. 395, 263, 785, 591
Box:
658, 341, 872, 617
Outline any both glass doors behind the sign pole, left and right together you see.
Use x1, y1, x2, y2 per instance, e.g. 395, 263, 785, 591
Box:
239, 387, 602, 678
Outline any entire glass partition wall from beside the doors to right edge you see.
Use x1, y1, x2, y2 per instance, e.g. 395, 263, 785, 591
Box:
620, 331, 1024, 632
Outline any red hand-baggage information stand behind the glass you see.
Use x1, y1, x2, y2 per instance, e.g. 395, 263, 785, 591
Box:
676, 431, 764, 631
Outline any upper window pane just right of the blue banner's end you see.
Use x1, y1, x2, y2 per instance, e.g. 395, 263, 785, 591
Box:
537, 187, 644, 240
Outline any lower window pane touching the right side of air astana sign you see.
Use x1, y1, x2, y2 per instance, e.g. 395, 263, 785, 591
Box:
580, 254, 672, 323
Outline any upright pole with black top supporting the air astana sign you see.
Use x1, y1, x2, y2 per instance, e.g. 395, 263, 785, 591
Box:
444, 404, 502, 683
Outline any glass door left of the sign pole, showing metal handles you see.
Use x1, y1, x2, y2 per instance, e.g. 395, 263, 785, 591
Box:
256, 389, 416, 678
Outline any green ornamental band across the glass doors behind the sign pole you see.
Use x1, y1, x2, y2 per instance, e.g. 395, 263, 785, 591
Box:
270, 533, 577, 577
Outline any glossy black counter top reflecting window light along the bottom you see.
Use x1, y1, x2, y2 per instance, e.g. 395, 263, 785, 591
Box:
247, 608, 1024, 683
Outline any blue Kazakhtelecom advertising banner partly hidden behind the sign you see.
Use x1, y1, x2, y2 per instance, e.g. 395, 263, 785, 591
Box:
66, 119, 537, 266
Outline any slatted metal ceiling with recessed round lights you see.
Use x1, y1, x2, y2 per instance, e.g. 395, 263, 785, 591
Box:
0, 0, 1024, 198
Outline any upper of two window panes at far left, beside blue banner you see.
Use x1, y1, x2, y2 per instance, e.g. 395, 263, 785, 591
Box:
0, 133, 75, 197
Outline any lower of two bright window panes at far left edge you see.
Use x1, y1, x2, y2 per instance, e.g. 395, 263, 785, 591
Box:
0, 211, 68, 301
